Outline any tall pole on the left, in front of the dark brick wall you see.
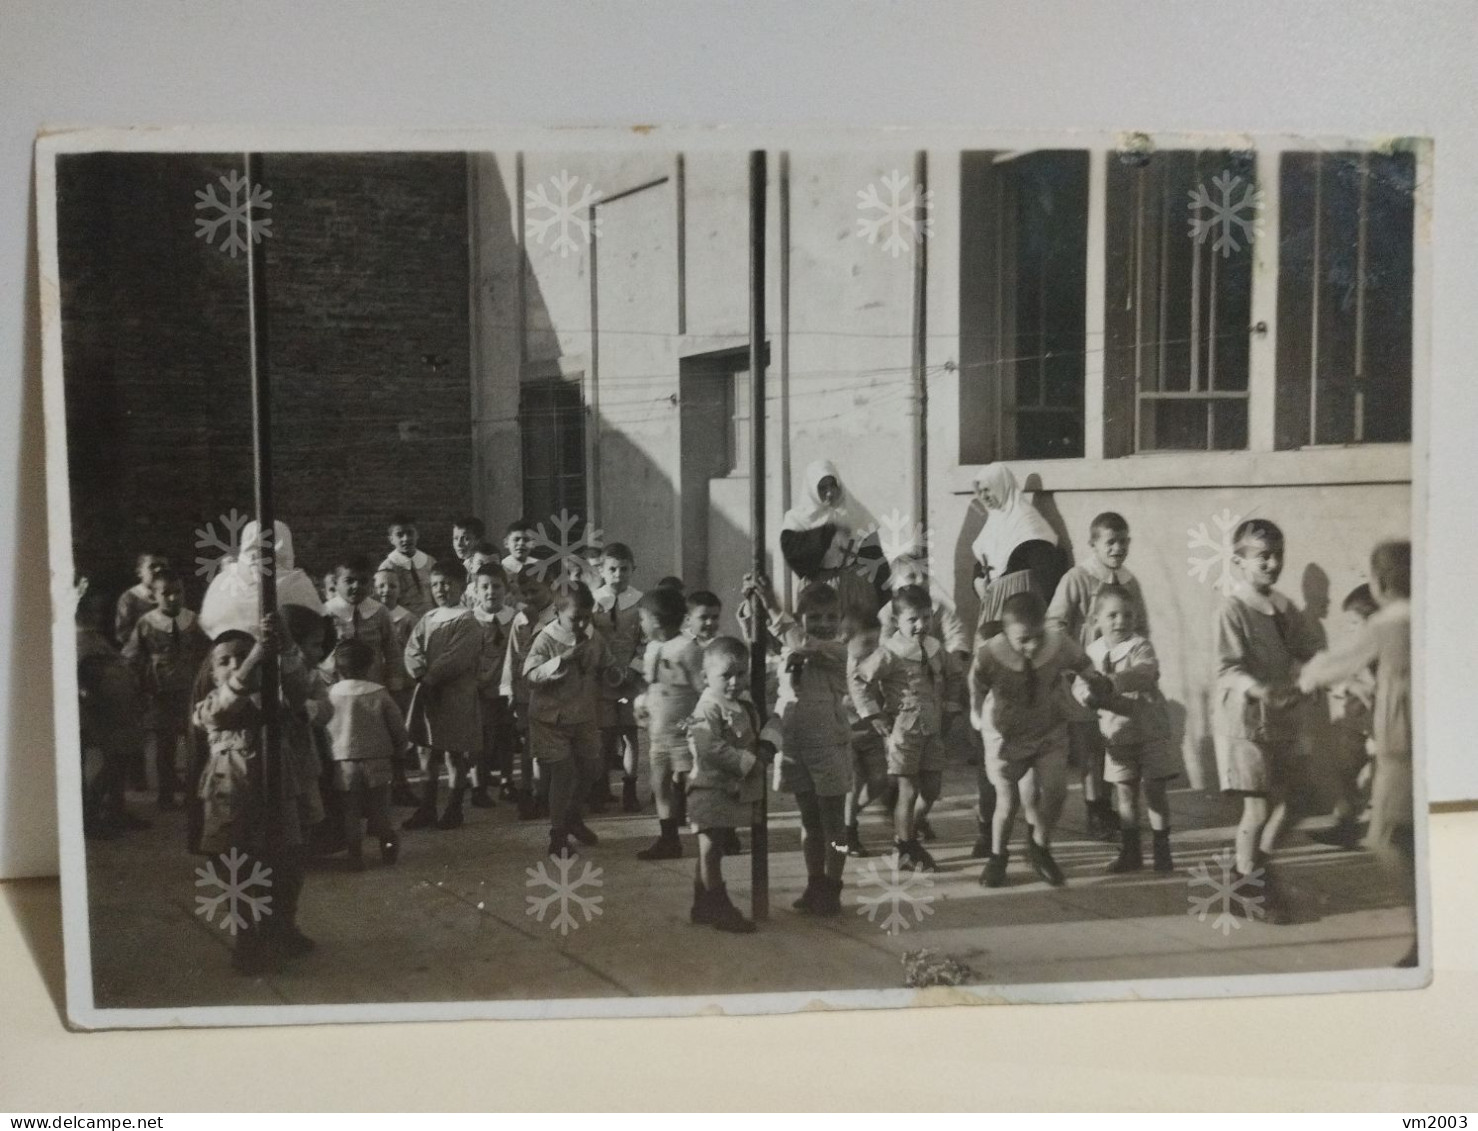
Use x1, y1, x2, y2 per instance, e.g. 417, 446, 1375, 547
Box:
245, 154, 282, 847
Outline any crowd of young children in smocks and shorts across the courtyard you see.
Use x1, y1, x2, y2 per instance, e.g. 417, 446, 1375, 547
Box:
80, 499, 1411, 970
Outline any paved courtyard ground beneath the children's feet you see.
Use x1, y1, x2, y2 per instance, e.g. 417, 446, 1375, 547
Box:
87, 766, 1409, 1008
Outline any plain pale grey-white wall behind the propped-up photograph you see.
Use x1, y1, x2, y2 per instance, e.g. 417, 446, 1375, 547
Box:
0, 0, 1478, 878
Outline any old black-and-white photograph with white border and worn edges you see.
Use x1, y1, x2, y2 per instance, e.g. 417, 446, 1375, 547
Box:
37, 129, 1432, 1028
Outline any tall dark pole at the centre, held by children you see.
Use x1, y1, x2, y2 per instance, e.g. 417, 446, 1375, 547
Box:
749, 149, 770, 920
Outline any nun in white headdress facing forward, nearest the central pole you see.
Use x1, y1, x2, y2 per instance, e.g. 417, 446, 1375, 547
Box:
780, 460, 888, 612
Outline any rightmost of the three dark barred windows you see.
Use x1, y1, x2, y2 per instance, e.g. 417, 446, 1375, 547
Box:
1276, 152, 1416, 448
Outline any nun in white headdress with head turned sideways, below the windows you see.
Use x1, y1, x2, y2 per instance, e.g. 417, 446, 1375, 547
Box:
970, 463, 1066, 643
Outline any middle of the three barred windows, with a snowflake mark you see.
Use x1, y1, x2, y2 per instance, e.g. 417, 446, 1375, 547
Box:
1104, 151, 1258, 455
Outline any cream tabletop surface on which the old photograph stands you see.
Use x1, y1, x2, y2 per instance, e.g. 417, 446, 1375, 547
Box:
0, 812, 1478, 1113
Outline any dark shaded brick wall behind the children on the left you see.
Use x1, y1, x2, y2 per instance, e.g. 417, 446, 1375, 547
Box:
58, 154, 471, 612
